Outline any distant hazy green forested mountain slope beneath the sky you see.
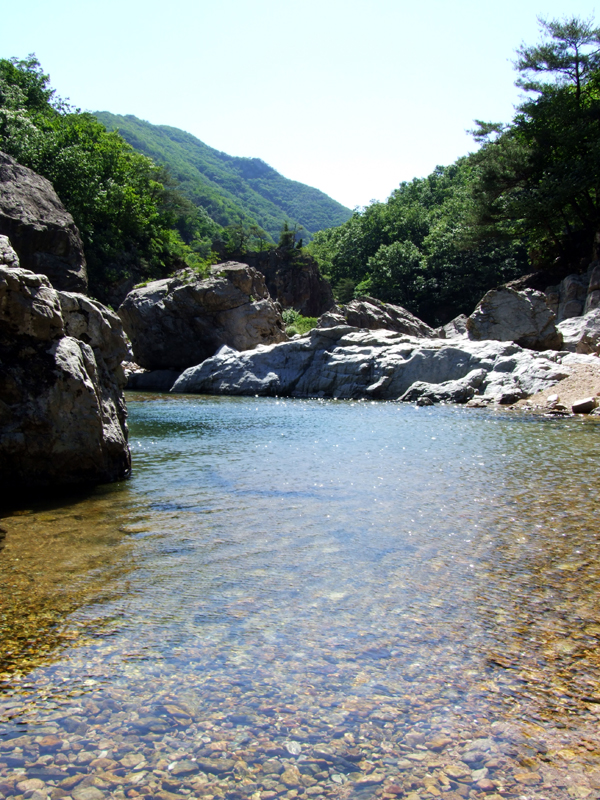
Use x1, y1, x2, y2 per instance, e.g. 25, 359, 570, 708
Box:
95, 111, 351, 241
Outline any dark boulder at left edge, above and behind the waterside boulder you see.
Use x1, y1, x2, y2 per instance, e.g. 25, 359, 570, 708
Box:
0, 153, 87, 292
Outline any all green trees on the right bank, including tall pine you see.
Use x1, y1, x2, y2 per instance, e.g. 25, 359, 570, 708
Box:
311, 18, 600, 325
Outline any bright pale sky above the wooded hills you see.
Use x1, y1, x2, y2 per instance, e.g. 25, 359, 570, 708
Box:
0, 0, 600, 208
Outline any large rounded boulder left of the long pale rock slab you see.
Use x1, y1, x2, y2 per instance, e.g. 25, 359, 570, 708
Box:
118, 261, 287, 370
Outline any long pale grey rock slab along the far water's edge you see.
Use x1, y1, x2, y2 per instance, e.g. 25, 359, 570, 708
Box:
171, 326, 580, 402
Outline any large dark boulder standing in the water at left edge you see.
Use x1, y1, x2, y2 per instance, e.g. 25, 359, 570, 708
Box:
0, 238, 131, 489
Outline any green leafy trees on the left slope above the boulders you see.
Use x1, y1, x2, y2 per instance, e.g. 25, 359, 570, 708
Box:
0, 56, 207, 299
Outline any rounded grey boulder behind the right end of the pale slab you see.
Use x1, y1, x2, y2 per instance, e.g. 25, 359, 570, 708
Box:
467, 287, 562, 350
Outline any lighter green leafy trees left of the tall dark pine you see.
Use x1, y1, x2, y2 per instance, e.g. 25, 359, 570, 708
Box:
310, 158, 526, 325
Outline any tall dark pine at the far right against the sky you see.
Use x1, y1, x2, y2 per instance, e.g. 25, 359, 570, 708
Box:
474, 19, 600, 269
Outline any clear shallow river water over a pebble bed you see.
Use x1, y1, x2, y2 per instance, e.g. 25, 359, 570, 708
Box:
0, 395, 600, 800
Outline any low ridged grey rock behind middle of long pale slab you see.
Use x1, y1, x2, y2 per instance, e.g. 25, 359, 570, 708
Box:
319, 297, 435, 339
